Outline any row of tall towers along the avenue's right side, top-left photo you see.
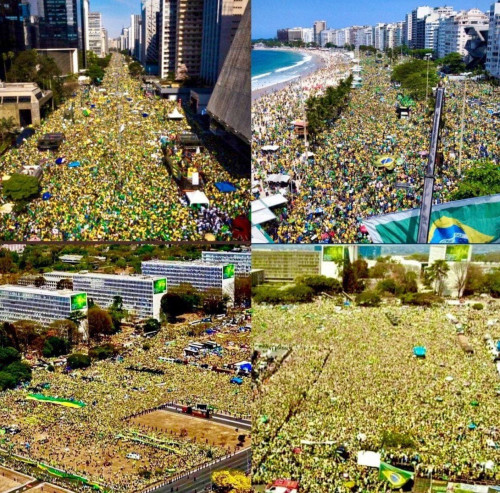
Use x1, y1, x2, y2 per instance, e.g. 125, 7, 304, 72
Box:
111, 0, 249, 85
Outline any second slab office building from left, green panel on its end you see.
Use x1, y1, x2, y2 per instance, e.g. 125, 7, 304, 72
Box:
72, 272, 167, 320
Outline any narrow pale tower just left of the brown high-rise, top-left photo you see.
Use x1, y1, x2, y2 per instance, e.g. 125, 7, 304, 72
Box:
141, 0, 160, 73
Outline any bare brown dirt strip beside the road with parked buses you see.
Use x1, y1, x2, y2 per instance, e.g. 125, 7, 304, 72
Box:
130, 411, 250, 450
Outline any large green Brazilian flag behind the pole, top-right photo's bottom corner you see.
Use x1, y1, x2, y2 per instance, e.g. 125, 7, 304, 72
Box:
363, 194, 500, 244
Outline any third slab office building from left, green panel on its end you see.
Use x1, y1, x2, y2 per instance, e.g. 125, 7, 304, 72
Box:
141, 260, 235, 299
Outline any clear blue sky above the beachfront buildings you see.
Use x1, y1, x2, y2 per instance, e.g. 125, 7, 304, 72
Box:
252, 0, 494, 39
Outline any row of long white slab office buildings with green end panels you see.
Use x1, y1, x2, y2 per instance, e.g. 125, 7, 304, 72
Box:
0, 252, 251, 326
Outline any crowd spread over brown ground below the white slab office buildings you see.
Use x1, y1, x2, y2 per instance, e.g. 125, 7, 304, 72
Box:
0, 312, 250, 492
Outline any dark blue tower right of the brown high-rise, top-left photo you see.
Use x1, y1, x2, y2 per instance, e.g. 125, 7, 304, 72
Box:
200, 0, 248, 85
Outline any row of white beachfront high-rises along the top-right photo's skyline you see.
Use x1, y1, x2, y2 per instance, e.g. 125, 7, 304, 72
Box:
277, 1, 500, 77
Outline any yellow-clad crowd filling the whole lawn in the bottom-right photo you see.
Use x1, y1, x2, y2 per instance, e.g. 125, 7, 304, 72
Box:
253, 301, 500, 493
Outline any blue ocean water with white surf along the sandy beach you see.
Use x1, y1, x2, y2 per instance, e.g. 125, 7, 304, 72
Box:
252, 49, 314, 91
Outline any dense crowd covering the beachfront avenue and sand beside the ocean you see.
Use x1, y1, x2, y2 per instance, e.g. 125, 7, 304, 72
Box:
252, 50, 500, 243
